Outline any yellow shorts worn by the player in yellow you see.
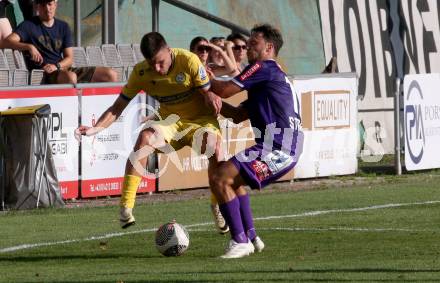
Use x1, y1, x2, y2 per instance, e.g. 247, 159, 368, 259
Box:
152, 116, 221, 150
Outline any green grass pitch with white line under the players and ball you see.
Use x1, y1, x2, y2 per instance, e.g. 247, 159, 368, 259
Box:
0, 172, 440, 283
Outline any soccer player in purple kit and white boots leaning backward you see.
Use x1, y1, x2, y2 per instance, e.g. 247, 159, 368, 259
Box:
210, 24, 303, 258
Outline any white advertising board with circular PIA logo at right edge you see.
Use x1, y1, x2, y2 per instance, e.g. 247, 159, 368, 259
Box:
403, 74, 440, 170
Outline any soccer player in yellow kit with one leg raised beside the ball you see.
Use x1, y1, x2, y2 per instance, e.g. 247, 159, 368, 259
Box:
76, 32, 222, 228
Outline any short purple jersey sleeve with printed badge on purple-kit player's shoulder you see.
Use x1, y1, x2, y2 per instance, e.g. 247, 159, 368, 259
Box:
232, 62, 270, 90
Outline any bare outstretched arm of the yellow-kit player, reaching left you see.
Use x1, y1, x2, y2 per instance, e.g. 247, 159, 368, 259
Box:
75, 96, 129, 139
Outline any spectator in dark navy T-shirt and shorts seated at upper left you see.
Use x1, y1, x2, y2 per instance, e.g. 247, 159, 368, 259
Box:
0, 0, 117, 84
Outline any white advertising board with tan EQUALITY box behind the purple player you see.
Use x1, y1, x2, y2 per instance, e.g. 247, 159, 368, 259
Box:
293, 74, 358, 178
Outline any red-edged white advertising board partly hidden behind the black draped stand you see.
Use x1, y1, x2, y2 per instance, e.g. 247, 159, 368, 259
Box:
0, 86, 79, 198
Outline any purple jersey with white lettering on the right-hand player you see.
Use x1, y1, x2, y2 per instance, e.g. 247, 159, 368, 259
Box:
232, 60, 301, 155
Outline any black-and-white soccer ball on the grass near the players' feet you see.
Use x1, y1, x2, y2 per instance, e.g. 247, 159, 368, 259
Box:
155, 222, 189, 256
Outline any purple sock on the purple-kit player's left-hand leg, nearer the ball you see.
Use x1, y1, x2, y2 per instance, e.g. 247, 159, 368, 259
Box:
219, 198, 248, 243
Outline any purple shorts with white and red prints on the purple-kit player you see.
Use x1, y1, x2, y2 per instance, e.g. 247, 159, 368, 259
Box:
230, 144, 297, 189
